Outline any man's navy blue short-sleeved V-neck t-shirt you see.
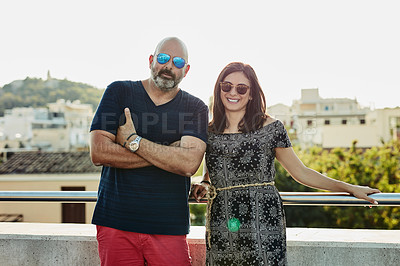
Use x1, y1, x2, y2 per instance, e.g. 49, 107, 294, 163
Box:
90, 81, 208, 235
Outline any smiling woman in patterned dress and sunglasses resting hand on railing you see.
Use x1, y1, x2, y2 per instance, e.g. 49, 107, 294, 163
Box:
193, 62, 380, 265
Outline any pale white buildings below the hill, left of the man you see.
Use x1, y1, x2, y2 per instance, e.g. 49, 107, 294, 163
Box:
0, 99, 93, 151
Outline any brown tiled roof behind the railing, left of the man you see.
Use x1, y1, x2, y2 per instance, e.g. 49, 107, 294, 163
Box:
0, 152, 101, 174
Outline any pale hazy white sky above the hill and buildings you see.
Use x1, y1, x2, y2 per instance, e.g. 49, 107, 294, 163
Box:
0, 0, 400, 108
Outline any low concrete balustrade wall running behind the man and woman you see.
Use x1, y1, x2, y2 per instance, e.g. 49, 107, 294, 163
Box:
0, 223, 400, 266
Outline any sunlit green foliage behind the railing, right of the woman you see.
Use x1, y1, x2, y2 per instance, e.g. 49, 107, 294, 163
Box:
277, 141, 400, 229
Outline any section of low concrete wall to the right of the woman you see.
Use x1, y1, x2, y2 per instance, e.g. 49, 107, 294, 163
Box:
287, 228, 400, 266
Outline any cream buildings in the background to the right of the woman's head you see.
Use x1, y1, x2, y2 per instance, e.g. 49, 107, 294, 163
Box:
268, 89, 400, 148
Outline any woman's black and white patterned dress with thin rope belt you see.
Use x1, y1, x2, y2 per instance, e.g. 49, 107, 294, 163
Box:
206, 120, 291, 265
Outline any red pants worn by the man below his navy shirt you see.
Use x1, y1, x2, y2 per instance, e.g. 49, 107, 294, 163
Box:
96, 225, 191, 266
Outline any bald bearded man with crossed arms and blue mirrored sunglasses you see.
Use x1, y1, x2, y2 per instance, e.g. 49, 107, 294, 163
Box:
90, 37, 208, 265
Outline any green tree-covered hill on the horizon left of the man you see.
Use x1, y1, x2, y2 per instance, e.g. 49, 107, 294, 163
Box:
0, 77, 104, 116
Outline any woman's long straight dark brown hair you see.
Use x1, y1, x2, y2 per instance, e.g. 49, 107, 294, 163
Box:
208, 62, 267, 133
